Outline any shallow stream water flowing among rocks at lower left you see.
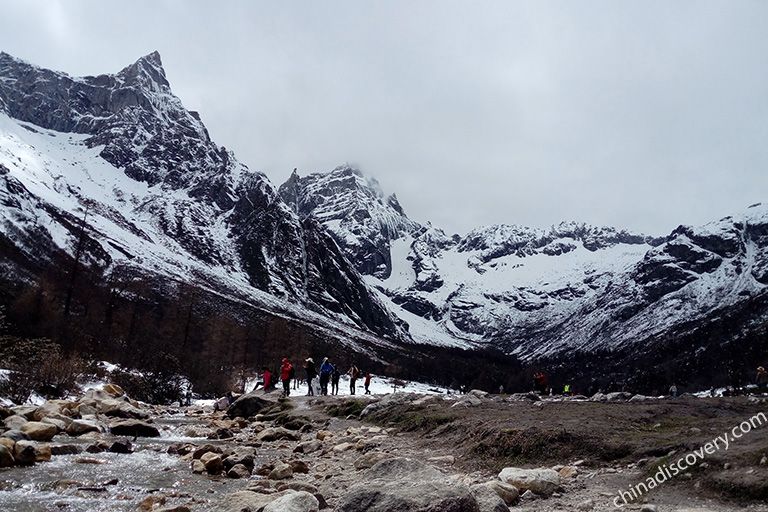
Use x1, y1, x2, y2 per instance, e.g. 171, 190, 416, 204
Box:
0, 416, 254, 512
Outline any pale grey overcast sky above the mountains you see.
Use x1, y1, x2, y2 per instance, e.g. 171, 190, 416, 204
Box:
0, 0, 768, 234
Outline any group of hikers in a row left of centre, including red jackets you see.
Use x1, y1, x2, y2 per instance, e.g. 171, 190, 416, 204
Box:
257, 357, 372, 397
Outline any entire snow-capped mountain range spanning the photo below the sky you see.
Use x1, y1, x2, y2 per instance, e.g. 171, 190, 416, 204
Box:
0, 53, 768, 378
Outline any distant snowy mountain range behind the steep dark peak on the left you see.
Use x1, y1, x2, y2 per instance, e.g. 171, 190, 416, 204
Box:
281, 164, 768, 358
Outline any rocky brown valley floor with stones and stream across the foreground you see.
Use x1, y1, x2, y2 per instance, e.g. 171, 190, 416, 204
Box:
0, 393, 768, 512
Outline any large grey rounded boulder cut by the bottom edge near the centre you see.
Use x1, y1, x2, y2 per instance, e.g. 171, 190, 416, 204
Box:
336, 458, 481, 512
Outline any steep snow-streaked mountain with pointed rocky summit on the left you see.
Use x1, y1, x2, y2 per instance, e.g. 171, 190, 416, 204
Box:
0, 53, 405, 339
